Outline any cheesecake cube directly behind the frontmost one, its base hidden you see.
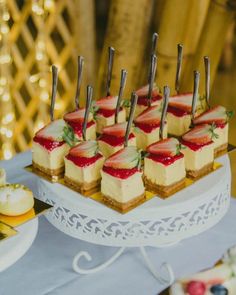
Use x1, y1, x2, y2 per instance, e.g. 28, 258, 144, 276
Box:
98, 122, 136, 158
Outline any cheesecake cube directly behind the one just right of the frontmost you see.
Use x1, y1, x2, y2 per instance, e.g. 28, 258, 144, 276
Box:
134, 106, 169, 151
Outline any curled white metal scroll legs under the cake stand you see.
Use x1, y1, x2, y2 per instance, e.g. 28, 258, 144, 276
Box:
72, 247, 175, 285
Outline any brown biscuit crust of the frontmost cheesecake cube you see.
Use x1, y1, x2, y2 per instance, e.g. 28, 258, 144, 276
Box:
102, 192, 146, 213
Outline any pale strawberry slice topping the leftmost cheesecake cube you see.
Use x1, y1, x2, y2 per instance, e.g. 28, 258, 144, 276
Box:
35, 119, 67, 141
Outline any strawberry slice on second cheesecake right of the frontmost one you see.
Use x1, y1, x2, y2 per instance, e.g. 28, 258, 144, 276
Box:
182, 124, 214, 144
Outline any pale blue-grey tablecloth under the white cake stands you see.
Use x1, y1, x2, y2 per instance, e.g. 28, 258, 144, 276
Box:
0, 152, 236, 295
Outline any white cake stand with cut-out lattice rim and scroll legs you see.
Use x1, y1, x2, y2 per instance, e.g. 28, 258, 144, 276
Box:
37, 155, 231, 283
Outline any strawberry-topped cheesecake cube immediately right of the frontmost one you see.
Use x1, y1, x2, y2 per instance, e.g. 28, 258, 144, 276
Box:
144, 138, 186, 197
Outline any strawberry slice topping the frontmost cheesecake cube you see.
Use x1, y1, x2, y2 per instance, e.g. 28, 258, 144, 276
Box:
104, 146, 140, 169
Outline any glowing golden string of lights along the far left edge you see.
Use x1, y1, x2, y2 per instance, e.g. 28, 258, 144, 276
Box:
0, 0, 15, 160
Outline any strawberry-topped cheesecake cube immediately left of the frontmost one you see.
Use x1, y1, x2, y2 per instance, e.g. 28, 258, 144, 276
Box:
64, 140, 104, 195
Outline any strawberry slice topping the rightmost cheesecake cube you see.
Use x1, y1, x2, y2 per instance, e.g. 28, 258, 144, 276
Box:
193, 106, 228, 125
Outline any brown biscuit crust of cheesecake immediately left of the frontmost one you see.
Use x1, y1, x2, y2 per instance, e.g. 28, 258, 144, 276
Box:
64, 176, 101, 196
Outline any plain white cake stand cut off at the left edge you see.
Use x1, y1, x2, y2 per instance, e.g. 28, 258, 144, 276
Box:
0, 218, 38, 272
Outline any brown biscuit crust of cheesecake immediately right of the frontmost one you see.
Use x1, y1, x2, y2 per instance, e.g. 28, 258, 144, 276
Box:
144, 176, 185, 198
